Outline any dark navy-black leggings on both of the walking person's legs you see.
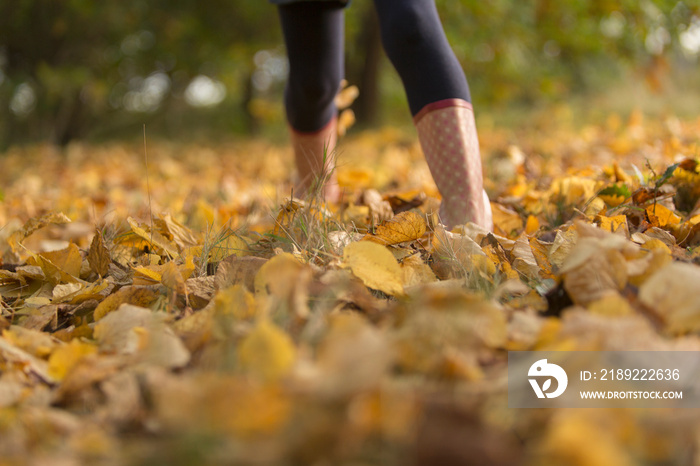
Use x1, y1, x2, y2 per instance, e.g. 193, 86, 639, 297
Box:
279, 0, 471, 132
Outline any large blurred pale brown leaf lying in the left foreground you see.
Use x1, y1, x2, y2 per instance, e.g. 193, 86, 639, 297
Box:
95, 304, 190, 368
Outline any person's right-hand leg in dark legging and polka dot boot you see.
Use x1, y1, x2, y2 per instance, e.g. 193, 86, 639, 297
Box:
374, 0, 493, 229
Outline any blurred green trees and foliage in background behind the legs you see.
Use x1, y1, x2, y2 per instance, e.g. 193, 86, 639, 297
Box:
0, 0, 700, 146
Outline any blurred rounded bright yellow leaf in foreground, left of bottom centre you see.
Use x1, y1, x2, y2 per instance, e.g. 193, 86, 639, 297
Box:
238, 319, 296, 382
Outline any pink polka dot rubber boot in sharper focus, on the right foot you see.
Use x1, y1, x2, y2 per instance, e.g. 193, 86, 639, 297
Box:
413, 99, 493, 231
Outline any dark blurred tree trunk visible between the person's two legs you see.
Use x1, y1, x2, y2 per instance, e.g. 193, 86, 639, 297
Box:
350, 4, 382, 125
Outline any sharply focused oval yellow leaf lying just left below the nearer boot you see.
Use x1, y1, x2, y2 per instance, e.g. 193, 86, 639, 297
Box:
343, 241, 403, 296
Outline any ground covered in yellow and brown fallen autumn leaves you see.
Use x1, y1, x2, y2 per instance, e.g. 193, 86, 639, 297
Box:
0, 113, 700, 466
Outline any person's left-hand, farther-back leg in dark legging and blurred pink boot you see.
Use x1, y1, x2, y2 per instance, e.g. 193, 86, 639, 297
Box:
279, 2, 344, 199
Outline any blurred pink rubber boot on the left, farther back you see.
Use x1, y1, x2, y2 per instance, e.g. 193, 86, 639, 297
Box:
290, 118, 340, 202
